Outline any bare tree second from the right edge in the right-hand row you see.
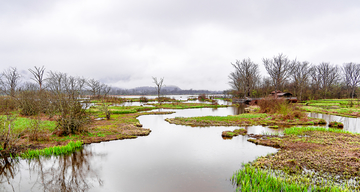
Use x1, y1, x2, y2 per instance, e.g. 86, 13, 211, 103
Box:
316, 62, 339, 99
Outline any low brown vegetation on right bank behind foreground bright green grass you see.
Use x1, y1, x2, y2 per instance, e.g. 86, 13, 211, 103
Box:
250, 131, 360, 178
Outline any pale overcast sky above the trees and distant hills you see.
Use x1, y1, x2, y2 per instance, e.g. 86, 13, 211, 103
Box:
0, 0, 360, 90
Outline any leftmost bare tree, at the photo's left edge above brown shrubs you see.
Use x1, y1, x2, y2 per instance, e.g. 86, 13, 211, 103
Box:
1, 67, 21, 97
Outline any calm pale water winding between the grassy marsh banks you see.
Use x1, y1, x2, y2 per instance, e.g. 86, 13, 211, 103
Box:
0, 104, 360, 192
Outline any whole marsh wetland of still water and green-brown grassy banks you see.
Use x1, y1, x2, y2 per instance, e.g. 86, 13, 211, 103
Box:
0, 97, 360, 191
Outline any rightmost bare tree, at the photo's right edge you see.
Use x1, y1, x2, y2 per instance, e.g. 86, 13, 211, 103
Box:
342, 63, 360, 99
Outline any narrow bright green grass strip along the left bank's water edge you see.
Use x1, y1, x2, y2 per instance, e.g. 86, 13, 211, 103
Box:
20, 141, 83, 159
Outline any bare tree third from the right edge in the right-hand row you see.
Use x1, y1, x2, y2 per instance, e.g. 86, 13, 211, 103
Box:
291, 60, 311, 100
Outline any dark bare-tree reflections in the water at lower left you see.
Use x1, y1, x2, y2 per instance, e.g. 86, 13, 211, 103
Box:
0, 147, 104, 191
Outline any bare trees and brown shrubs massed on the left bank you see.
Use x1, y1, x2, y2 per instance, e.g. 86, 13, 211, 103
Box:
0, 67, 111, 144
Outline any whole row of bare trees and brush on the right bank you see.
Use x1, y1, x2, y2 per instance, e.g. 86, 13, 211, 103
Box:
227, 53, 360, 100
